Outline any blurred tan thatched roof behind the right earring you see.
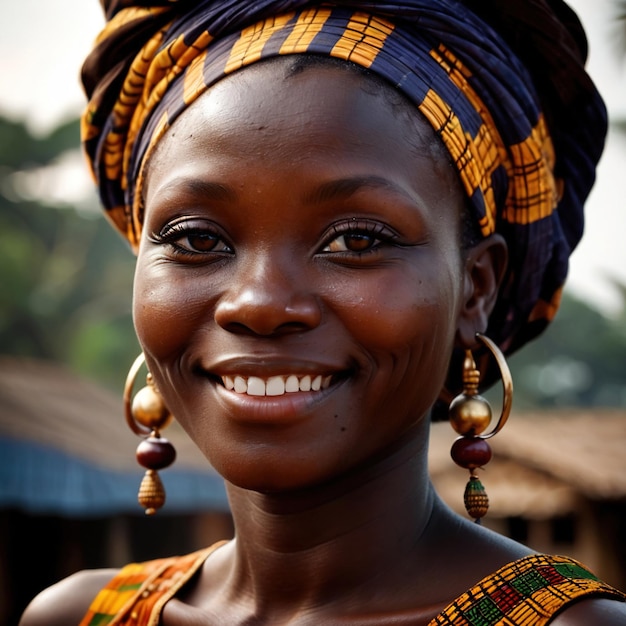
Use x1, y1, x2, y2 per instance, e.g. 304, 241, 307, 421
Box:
430, 408, 626, 518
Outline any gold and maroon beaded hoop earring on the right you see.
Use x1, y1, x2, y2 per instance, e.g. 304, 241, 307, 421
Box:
448, 333, 513, 524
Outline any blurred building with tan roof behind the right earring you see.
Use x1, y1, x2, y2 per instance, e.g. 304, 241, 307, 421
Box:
430, 408, 626, 589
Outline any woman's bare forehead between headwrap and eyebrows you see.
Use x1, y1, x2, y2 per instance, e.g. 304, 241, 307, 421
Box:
145, 58, 450, 194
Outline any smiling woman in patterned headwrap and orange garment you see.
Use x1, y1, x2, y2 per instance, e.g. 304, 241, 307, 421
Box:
22, 0, 626, 626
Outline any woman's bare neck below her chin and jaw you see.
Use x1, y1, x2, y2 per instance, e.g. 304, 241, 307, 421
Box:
219, 424, 435, 610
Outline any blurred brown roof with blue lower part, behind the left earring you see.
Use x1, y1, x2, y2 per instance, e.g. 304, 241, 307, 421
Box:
0, 357, 227, 515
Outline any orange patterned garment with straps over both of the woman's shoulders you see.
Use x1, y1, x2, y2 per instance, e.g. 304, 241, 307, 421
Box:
79, 542, 626, 626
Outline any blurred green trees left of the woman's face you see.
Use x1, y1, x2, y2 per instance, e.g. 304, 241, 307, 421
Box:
0, 111, 138, 390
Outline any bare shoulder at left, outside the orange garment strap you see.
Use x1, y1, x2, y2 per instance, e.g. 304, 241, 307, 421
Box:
19, 569, 117, 626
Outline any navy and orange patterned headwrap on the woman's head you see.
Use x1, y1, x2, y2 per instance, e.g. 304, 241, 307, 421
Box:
82, 0, 606, 368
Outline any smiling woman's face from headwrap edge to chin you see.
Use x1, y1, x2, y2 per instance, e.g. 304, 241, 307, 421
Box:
134, 61, 465, 491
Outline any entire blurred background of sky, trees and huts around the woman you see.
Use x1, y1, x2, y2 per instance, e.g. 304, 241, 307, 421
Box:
0, 0, 626, 625
